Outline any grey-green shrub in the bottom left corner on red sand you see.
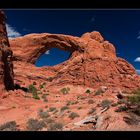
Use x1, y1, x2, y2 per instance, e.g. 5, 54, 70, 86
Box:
0, 121, 17, 131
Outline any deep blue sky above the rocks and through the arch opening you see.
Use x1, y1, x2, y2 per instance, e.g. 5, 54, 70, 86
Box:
5, 10, 140, 73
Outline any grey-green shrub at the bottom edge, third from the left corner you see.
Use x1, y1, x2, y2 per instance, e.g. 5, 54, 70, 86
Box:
48, 122, 63, 131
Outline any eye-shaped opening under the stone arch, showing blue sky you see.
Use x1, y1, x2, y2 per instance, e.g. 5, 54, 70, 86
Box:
35, 48, 71, 67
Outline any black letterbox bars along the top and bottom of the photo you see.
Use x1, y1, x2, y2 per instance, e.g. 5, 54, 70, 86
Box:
0, 0, 140, 140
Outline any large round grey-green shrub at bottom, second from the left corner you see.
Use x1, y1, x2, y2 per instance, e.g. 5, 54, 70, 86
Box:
27, 118, 46, 131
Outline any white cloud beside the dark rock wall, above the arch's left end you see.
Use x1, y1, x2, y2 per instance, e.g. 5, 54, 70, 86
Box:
6, 24, 21, 38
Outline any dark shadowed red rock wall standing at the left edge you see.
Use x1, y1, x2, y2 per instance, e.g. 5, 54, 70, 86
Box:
0, 10, 14, 90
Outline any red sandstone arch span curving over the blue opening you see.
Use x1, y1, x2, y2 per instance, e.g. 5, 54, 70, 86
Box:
10, 33, 82, 64
